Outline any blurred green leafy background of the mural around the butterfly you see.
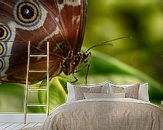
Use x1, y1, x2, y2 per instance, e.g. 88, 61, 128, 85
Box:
0, 0, 163, 113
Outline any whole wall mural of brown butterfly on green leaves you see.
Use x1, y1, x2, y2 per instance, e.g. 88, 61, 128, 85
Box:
0, 0, 163, 112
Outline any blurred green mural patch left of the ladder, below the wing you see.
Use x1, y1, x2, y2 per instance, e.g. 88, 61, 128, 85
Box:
0, 83, 24, 113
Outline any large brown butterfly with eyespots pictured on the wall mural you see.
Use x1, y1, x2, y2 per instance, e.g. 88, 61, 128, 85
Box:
0, 0, 87, 83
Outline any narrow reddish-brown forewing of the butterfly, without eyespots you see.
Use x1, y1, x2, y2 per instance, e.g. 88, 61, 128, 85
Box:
57, 0, 86, 54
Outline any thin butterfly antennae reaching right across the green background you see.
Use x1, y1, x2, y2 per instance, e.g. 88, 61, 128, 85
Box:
86, 36, 132, 53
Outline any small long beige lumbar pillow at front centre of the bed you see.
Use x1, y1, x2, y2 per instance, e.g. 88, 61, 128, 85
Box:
84, 93, 125, 99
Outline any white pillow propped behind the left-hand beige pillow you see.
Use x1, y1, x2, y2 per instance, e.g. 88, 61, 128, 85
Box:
66, 81, 110, 103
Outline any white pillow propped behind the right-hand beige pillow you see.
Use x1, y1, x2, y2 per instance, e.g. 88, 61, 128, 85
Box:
109, 83, 150, 102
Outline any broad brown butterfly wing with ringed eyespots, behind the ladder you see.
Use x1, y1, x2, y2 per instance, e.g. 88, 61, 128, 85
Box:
0, 0, 66, 83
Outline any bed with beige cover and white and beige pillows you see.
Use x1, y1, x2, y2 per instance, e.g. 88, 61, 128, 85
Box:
42, 83, 163, 130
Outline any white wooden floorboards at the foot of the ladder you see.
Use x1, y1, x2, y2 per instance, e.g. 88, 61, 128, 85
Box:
0, 123, 43, 130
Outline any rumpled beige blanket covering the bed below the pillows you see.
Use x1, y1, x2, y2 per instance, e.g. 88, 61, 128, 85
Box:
43, 98, 163, 130
